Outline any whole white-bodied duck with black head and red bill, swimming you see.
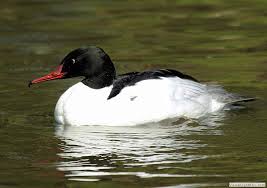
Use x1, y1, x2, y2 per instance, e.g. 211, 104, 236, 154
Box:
29, 46, 253, 126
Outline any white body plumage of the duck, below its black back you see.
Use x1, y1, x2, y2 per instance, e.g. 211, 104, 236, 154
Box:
55, 77, 225, 126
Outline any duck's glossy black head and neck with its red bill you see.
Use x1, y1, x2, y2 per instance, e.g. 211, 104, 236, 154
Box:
29, 46, 116, 89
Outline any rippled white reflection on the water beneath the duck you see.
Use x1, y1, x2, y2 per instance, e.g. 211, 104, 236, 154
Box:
56, 113, 224, 181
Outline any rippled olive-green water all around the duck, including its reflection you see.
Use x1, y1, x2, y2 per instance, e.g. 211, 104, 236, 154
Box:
0, 0, 267, 188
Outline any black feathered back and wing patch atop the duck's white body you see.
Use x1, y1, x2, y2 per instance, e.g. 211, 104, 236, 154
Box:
108, 69, 198, 99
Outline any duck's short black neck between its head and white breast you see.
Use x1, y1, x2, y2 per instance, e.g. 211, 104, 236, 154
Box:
82, 72, 116, 89
